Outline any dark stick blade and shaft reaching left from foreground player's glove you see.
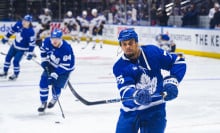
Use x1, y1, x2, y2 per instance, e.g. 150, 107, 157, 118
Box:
67, 81, 134, 105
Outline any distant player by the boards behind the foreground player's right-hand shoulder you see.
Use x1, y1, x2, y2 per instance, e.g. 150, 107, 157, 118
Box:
156, 34, 176, 52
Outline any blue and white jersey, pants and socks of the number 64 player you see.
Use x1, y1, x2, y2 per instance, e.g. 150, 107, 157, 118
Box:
40, 37, 75, 103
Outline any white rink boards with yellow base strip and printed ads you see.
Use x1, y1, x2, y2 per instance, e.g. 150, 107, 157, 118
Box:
0, 22, 220, 58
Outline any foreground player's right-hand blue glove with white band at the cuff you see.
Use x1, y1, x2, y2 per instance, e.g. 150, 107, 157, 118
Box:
163, 76, 178, 101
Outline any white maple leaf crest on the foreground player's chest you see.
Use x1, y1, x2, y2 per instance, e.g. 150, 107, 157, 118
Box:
136, 73, 157, 94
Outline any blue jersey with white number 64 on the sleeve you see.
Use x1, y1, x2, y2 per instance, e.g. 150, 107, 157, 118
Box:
40, 37, 75, 75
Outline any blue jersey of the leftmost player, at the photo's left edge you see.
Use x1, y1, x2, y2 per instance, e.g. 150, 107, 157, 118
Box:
6, 21, 35, 52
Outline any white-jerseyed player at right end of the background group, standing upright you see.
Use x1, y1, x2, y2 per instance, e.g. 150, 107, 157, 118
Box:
90, 9, 106, 49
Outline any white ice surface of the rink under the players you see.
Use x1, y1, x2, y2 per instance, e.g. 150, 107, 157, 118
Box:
0, 43, 220, 133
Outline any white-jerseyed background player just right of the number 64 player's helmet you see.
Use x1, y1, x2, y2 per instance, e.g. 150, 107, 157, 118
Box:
63, 11, 80, 43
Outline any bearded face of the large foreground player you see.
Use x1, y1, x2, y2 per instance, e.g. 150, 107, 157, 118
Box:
121, 39, 139, 59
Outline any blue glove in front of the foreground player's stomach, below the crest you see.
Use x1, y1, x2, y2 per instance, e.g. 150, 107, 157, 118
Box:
133, 89, 152, 105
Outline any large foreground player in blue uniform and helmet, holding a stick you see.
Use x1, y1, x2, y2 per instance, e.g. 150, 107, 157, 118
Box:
113, 29, 186, 133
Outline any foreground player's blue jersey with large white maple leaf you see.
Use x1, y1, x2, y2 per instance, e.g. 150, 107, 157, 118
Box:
113, 45, 186, 112
